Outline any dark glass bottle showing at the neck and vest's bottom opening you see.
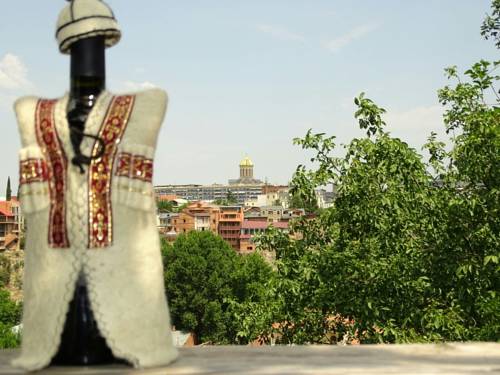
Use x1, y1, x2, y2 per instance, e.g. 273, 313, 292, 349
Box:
52, 36, 117, 366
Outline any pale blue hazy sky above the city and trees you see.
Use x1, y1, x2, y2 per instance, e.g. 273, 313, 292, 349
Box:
0, 0, 498, 189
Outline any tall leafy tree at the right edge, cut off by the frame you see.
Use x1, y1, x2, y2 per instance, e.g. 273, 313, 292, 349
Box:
428, 62, 500, 340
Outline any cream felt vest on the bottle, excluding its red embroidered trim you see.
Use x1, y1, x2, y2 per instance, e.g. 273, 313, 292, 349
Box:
13, 89, 177, 370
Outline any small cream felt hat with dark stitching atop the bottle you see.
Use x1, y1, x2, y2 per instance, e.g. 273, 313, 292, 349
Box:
56, 0, 121, 54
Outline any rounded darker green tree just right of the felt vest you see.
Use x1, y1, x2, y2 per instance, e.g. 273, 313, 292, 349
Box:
162, 231, 271, 344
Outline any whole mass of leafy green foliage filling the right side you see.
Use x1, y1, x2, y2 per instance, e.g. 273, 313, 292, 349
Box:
231, 7, 500, 344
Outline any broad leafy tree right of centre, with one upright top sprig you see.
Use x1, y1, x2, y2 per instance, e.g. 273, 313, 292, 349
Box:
247, 94, 442, 343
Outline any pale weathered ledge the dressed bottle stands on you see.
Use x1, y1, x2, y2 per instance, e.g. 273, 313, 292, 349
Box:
0, 343, 500, 375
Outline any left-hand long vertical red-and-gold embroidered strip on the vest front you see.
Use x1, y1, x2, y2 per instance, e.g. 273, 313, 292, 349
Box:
35, 100, 69, 248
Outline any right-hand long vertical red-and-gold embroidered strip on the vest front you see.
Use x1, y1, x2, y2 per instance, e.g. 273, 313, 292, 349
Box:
88, 95, 135, 248
